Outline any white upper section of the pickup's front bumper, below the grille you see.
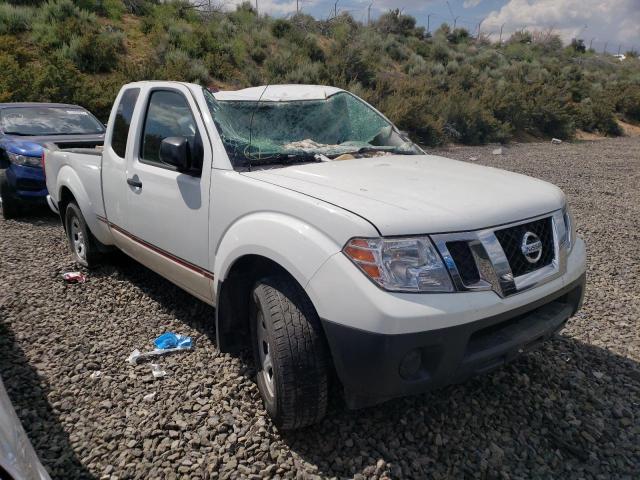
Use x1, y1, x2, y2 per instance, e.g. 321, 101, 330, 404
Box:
306, 240, 586, 335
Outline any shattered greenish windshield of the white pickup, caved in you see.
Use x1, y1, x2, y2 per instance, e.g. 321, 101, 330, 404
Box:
205, 90, 422, 166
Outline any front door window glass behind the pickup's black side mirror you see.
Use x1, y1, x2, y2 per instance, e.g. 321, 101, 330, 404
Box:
140, 90, 202, 173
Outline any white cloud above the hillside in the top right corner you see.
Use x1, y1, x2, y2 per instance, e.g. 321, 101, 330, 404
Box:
482, 0, 640, 48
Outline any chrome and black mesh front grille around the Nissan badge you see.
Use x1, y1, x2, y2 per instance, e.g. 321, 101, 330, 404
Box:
432, 210, 566, 297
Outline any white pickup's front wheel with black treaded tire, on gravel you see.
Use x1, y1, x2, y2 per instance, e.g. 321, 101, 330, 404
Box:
251, 276, 328, 430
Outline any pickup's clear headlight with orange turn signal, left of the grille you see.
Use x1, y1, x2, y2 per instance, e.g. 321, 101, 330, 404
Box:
343, 237, 454, 292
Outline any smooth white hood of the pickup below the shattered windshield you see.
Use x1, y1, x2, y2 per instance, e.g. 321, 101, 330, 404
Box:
245, 155, 565, 235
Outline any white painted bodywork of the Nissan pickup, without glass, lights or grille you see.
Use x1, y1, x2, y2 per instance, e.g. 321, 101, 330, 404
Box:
46, 82, 585, 334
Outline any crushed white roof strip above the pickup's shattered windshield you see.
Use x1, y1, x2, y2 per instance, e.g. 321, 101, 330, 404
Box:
213, 85, 344, 102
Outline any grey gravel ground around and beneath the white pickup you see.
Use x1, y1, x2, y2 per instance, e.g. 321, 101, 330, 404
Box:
0, 139, 640, 479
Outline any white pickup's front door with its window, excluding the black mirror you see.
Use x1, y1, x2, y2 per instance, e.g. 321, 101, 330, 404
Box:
116, 84, 213, 303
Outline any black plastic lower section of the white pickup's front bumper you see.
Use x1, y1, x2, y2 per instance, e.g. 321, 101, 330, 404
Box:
323, 275, 585, 408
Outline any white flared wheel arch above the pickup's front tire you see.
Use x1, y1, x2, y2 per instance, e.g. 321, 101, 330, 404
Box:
213, 212, 342, 288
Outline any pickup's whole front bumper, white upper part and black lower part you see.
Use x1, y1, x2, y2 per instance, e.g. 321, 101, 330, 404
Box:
306, 239, 586, 408
